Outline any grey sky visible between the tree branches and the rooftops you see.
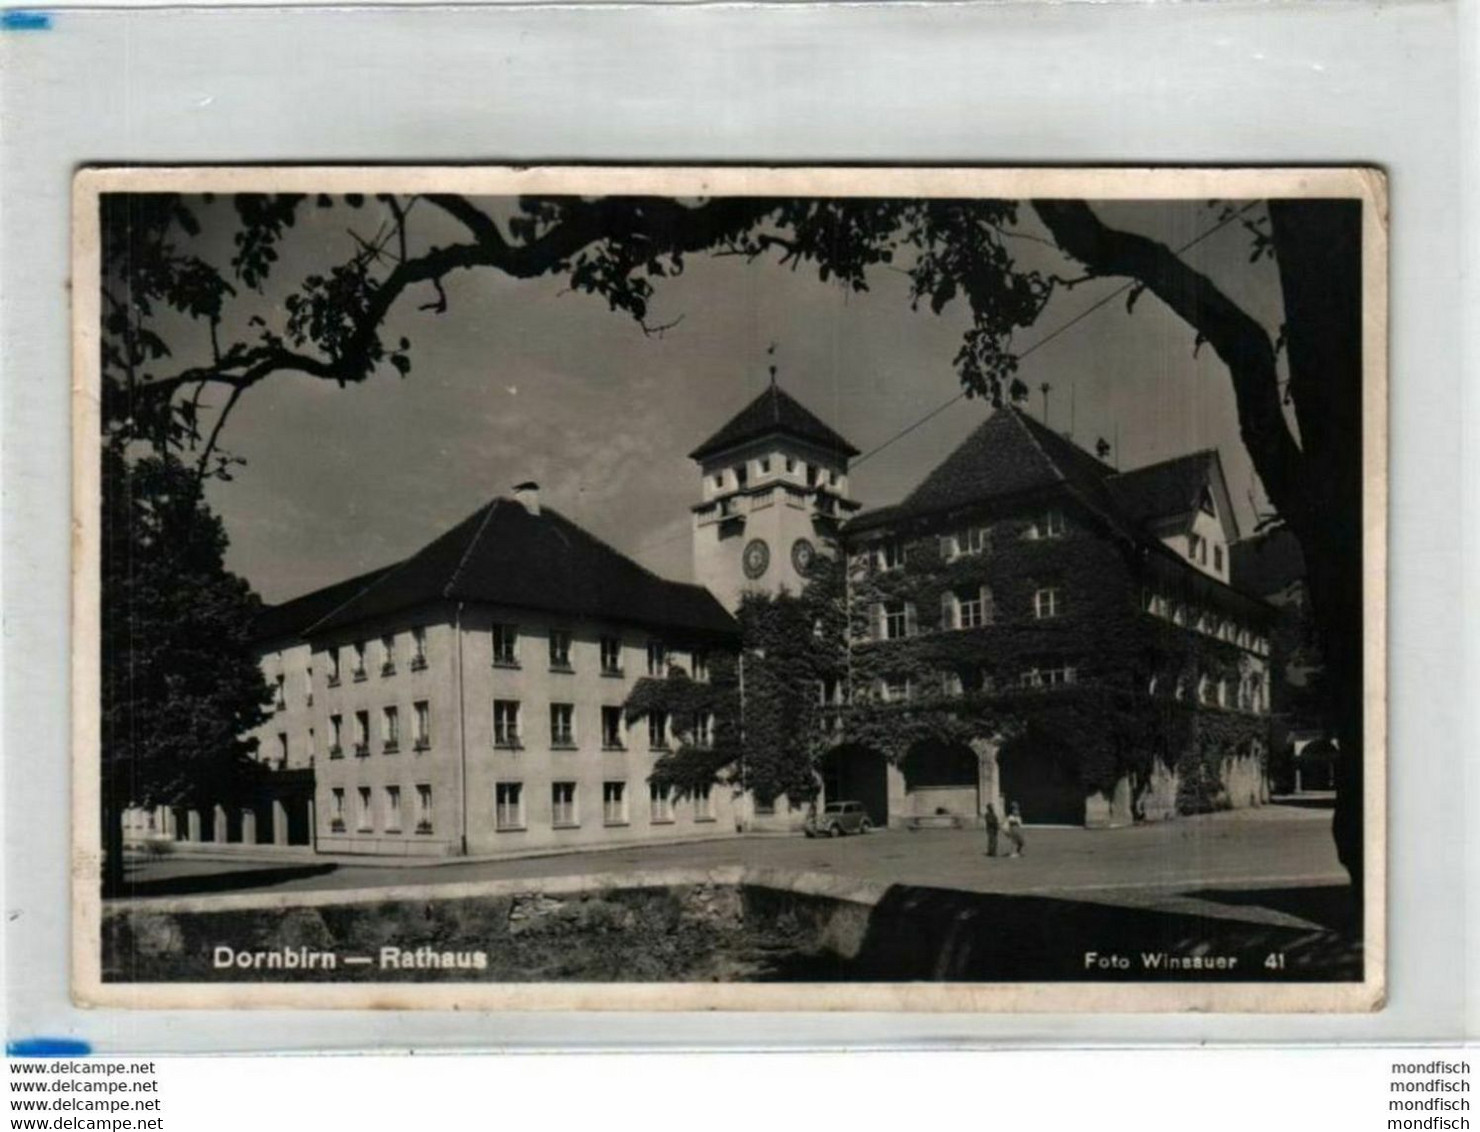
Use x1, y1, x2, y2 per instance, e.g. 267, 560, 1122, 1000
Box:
185, 201, 1280, 602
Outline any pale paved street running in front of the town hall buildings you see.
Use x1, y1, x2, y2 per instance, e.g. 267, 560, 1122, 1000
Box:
129, 805, 1345, 926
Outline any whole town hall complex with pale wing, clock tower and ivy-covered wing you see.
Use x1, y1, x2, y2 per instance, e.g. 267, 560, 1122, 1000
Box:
127, 377, 1276, 855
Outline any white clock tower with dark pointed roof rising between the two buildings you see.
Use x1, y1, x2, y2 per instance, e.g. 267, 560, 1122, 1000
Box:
688, 371, 860, 611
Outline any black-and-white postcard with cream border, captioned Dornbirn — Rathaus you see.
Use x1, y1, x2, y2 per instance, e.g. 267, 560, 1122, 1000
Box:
74, 166, 1387, 1012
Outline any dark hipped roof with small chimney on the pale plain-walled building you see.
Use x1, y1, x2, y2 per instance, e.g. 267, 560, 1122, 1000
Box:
309, 499, 737, 635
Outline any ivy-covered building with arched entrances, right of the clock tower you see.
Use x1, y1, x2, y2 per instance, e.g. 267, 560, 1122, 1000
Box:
820, 407, 1276, 826
